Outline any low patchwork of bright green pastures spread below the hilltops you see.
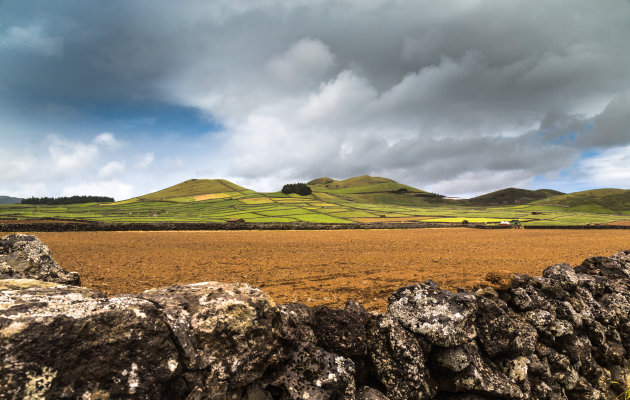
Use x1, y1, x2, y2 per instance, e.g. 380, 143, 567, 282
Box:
0, 193, 630, 226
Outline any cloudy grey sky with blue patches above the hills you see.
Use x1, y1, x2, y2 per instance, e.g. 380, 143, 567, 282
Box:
0, 0, 630, 200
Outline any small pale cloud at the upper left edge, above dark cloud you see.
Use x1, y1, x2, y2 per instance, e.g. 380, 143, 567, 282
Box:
0, 26, 63, 56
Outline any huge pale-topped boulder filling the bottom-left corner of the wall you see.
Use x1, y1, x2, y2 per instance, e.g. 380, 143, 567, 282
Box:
0, 284, 181, 399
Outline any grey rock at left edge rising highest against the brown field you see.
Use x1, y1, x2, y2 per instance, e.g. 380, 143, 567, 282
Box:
0, 234, 80, 286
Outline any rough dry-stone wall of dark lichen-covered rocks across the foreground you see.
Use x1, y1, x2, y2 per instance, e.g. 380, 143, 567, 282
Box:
0, 235, 630, 400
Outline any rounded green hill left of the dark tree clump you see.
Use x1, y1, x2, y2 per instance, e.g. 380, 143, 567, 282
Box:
138, 179, 252, 200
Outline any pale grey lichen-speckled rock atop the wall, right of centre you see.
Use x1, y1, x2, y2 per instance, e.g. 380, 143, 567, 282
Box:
388, 281, 477, 347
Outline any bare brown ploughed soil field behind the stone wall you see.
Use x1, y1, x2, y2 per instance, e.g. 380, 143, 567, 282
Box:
27, 228, 630, 310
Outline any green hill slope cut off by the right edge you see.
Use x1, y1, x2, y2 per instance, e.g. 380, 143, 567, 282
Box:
532, 189, 630, 214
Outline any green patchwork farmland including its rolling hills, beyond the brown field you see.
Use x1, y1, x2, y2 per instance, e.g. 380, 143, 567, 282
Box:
0, 176, 630, 226
